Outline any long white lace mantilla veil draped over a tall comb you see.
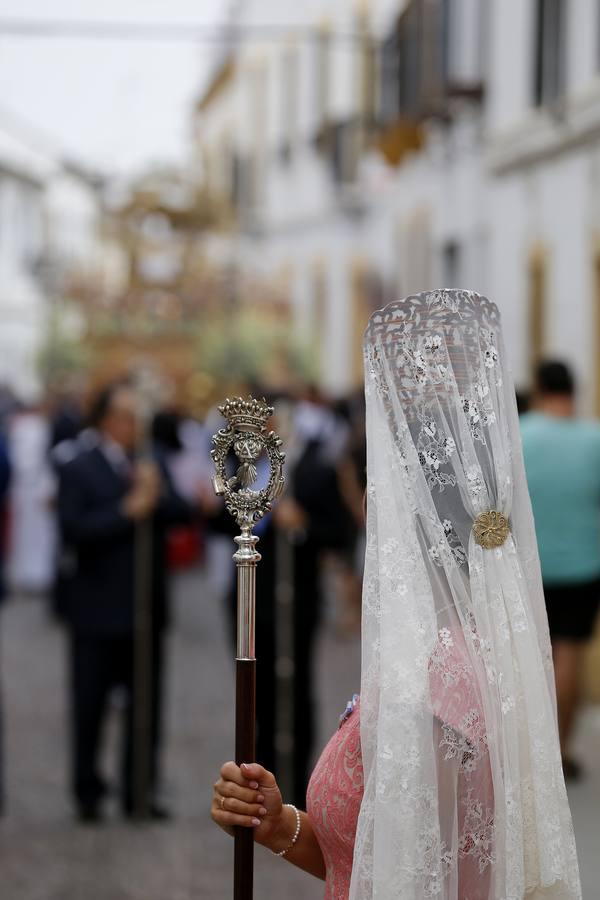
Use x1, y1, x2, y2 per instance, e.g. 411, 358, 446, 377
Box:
349, 290, 581, 900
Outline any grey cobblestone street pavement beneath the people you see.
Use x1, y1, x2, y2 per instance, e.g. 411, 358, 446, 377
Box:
0, 540, 600, 900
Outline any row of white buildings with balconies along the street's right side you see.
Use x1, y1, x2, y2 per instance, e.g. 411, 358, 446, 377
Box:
196, 0, 600, 412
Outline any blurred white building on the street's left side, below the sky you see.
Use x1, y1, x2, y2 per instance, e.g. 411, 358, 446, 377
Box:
0, 129, 107, 403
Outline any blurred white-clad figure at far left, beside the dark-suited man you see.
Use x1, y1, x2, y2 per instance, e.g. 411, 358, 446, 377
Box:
6, 405, 57, 594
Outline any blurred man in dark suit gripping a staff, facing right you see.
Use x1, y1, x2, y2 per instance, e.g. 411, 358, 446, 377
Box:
58, 384, 190, 821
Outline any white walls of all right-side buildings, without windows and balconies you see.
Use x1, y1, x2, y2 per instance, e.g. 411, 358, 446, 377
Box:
196, 0, 600, 409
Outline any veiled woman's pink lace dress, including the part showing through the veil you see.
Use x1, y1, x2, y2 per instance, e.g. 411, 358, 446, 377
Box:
307, 630, 494, 900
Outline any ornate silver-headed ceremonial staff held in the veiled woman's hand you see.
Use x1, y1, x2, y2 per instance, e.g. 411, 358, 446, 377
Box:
211, 397, 285, 900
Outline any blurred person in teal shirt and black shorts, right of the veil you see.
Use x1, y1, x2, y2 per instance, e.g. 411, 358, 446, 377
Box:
521, 362, 600, 778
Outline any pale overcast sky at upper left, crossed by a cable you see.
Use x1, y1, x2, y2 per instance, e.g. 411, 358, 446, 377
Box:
0, 0, 228, 175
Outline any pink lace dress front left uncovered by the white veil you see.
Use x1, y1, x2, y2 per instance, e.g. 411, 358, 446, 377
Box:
306, 704, 364, 900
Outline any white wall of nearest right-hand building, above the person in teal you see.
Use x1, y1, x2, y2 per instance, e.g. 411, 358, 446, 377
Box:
486, 0, 600, 411
